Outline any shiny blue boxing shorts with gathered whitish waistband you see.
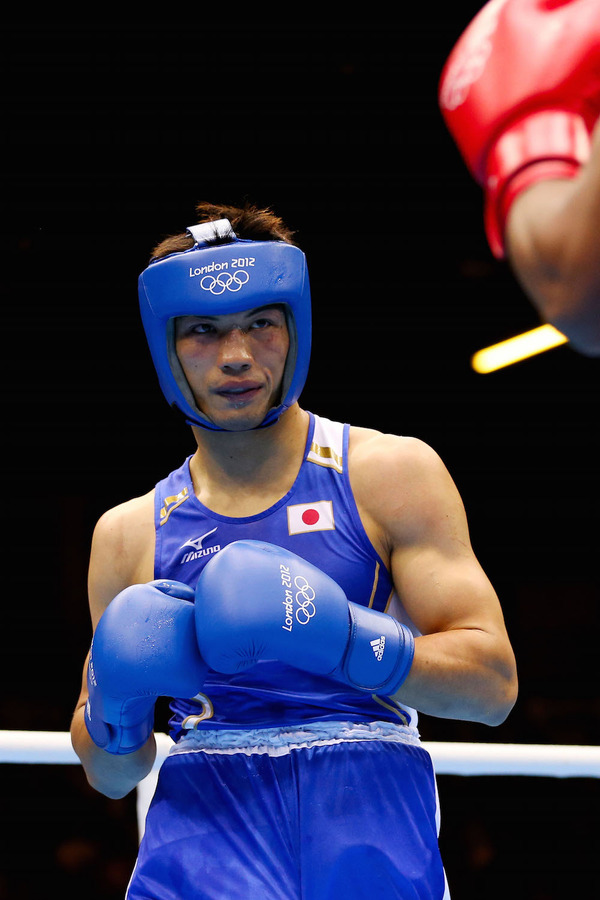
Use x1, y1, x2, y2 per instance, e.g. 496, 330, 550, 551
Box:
127, 722, 450, 900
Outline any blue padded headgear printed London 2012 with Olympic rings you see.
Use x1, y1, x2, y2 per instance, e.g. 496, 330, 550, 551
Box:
138, 219, 311, 431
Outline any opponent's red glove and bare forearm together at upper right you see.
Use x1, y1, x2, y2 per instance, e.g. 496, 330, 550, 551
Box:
439, 0, 600, 356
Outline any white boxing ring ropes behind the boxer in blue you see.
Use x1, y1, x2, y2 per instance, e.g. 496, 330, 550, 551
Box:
0, 731, 600, 837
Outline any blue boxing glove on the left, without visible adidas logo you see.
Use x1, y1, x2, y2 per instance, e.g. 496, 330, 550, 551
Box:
85, 581, 208, 754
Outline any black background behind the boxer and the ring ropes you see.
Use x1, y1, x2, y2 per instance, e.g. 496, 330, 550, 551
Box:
0, 8, 600, 900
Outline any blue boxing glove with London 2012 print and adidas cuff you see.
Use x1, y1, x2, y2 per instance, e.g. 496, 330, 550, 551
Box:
195, 541, 414, 695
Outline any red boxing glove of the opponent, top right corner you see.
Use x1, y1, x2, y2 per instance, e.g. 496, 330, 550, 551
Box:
439, 0, 600, 258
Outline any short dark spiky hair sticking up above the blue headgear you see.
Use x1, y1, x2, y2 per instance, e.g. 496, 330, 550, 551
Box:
151, 202, 295, 259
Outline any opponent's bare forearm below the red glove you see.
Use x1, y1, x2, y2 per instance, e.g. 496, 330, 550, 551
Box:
505, 118, 600, 356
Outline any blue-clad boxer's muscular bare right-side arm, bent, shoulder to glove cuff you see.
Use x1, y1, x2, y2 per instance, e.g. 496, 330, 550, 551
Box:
350, 435, 517, 725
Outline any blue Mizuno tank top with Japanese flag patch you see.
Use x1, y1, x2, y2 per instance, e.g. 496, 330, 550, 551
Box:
154, 413, 416, 740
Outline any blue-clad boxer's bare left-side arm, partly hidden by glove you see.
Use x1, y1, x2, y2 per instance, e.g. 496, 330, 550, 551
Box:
71, 494, 156, 798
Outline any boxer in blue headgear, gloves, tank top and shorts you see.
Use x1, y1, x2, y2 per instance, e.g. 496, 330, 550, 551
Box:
72, 204, 517, 900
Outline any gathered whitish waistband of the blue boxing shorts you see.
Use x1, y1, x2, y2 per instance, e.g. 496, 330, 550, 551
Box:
169, 722, 422, 756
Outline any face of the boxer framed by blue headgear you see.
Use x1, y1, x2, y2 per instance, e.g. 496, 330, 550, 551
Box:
175, 307, 290, 431
